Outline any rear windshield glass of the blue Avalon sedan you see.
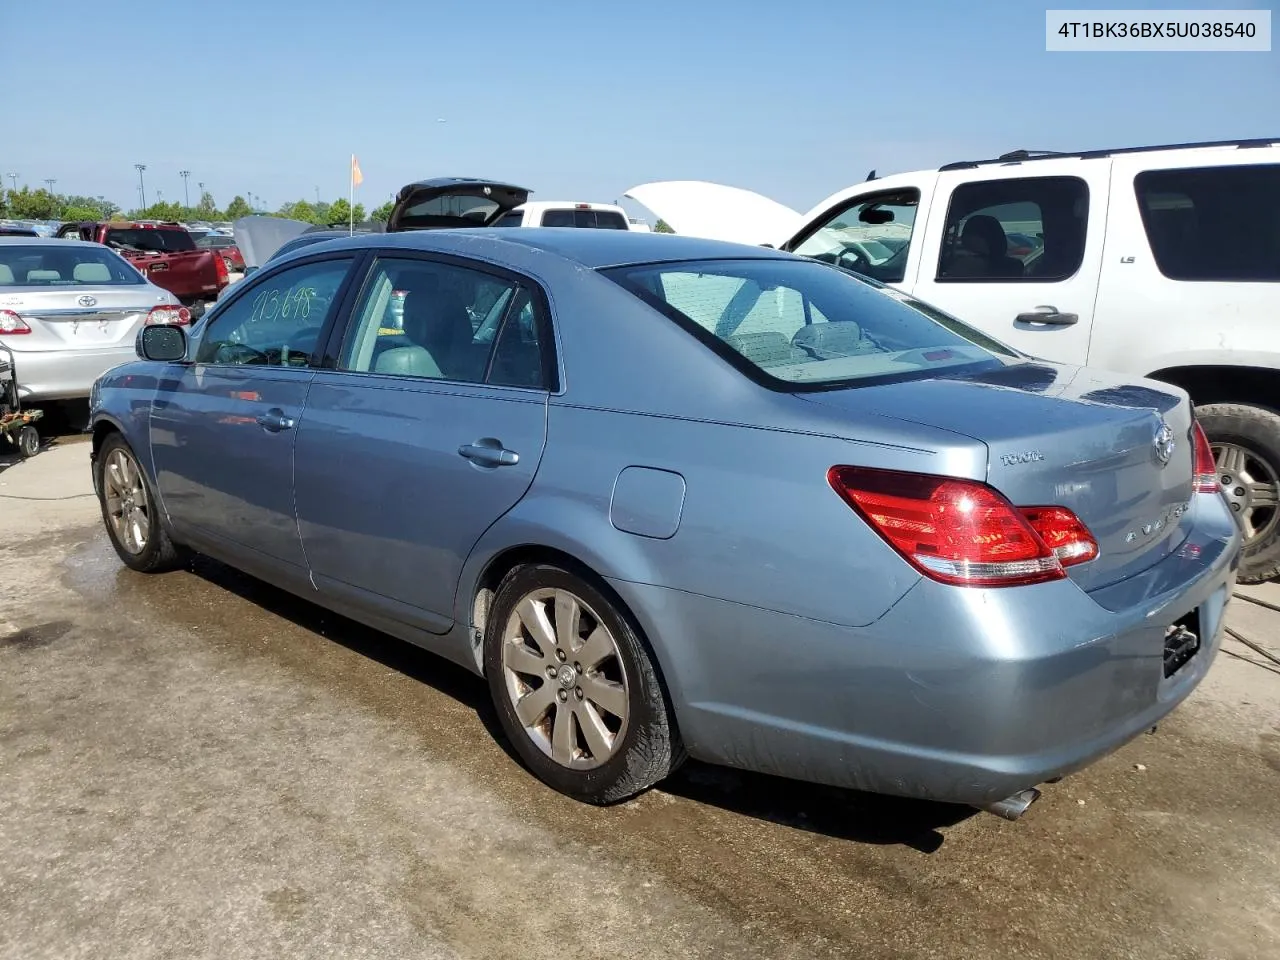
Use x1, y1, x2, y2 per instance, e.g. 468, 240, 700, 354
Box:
603, 260, 1019, 389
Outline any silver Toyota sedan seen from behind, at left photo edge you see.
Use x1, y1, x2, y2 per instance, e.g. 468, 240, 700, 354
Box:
0, 237, 191, 404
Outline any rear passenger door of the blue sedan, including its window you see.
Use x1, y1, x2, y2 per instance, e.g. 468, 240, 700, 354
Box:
296, 252, 554, 634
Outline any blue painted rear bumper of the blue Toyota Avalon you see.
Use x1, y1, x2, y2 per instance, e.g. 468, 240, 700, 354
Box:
614, 497, 1240, 805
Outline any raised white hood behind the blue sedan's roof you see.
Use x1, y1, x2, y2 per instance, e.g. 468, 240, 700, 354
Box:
623, 180, 803, 246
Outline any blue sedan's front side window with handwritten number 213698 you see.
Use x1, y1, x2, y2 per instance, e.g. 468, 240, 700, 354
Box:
196, 257, 353, 366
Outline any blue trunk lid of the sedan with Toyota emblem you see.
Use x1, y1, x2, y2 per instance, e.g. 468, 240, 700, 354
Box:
799, 362, 1194, 590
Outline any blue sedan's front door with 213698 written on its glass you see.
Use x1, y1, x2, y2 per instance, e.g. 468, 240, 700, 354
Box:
151, 253, 366, 570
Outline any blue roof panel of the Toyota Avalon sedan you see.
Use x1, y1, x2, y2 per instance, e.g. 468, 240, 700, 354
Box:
291, 227, 803, 269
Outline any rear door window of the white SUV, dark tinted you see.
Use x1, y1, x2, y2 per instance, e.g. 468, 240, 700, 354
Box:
937, 177, 1089, 283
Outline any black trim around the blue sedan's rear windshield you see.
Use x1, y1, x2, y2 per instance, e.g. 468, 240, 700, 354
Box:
596, 253, 1021, 393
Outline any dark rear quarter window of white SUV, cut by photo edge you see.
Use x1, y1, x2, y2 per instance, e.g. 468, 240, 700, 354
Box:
1134, 164, 1280, 283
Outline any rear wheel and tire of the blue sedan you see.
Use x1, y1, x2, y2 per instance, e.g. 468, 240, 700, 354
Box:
484, 564, 685, 804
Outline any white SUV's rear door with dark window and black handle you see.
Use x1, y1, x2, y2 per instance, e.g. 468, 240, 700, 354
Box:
910, 159, 1111, 364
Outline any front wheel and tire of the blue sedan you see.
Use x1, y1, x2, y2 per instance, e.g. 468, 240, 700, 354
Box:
93, 433, 187, 573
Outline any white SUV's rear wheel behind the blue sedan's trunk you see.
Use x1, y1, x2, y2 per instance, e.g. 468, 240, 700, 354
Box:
1196, 403, 1280, 584
